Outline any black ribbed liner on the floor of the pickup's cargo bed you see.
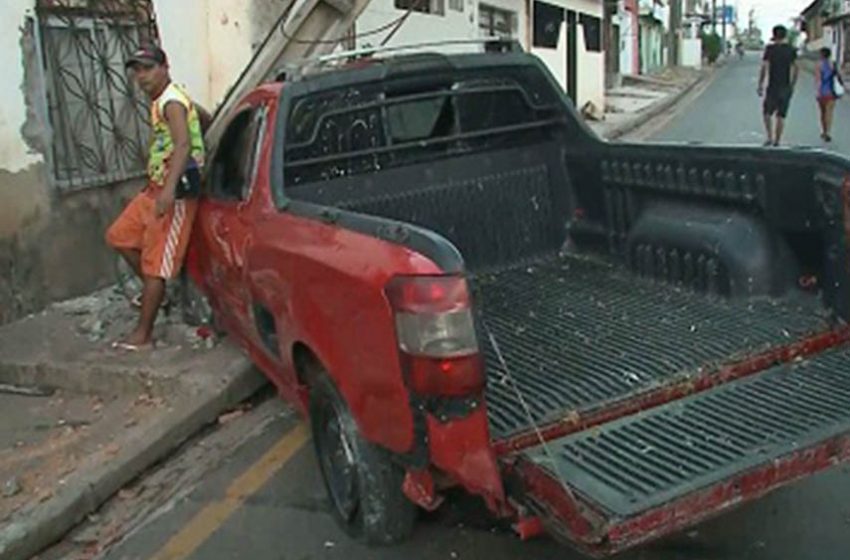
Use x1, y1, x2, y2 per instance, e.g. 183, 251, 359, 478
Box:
473, 257, 829, 439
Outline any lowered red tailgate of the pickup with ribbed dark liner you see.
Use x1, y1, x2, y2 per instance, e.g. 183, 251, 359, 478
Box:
515, 346, 850, 555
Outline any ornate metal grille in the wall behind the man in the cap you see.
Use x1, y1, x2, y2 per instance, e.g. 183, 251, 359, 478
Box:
36, 0, 157, 191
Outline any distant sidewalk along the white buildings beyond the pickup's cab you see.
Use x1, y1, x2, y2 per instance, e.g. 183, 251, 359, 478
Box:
586, 63, 722, 140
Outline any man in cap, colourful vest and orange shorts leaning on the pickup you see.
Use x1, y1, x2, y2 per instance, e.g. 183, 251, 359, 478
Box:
106, 46, 204, 350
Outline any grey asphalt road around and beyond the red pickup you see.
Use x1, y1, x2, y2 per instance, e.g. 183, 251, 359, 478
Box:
66, 55, 850, 560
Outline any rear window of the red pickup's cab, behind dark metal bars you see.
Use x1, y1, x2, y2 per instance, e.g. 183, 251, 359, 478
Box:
284, 64, 563, 186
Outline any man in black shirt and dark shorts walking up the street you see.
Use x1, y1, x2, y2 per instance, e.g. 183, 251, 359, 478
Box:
758, 25, 799, 146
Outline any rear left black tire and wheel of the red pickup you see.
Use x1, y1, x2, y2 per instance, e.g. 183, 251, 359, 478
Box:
310, 373, 416, 545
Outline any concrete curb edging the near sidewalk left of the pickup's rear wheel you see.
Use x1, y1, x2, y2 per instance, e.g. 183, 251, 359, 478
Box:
0, 357, 266, 560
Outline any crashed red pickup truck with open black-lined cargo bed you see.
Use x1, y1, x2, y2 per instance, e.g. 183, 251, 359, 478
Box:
188, 52, 850, 555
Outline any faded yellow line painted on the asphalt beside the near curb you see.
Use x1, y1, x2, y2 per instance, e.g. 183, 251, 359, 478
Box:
151, 423, 310, 560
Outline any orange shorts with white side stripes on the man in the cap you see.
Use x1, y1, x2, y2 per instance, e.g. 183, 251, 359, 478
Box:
106, 185, 198, 279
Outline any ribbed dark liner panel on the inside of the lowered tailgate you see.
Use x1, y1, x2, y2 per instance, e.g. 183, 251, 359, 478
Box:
526, 347, 850, 517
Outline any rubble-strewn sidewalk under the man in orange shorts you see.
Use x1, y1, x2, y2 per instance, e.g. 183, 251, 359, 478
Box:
0, 289, 265, 560
